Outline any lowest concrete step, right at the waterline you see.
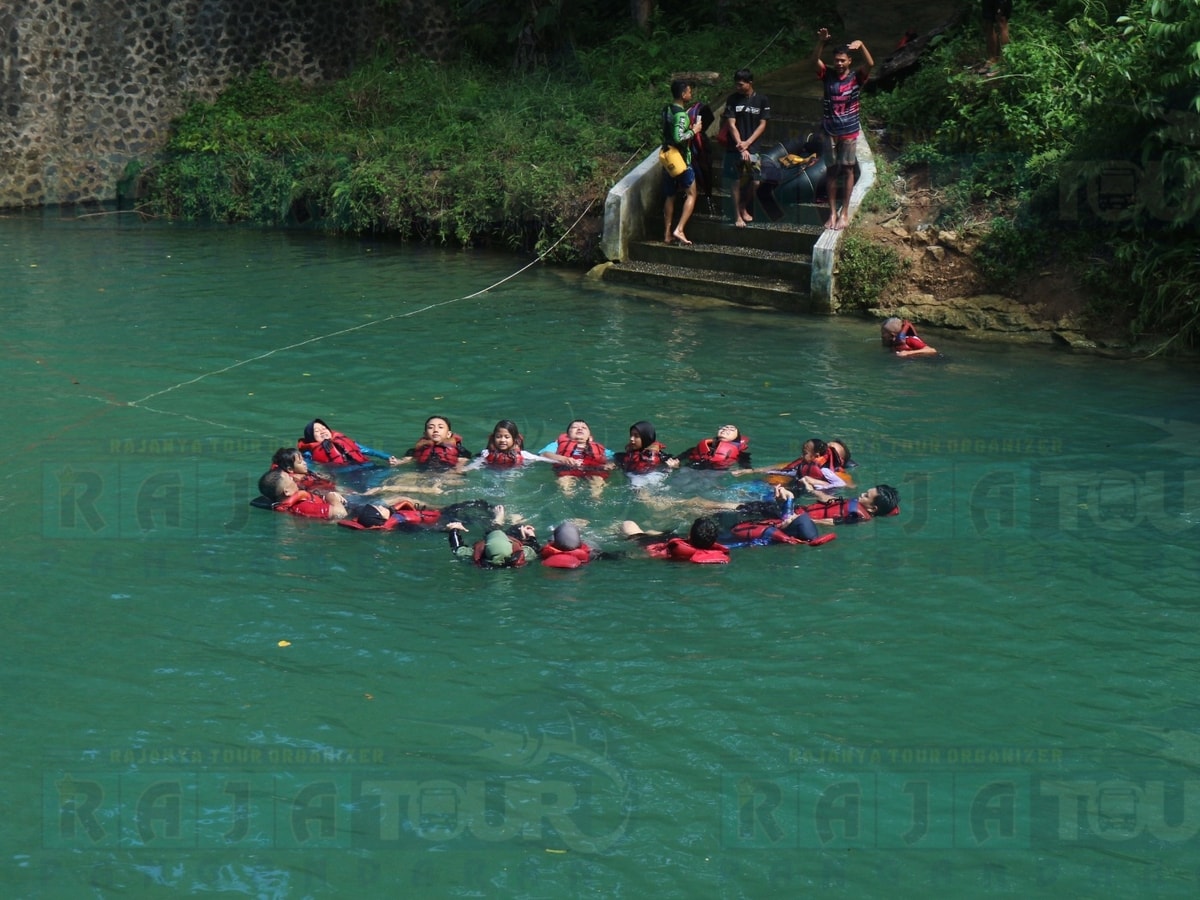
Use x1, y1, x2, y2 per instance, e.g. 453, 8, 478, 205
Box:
604, 260, 811, 312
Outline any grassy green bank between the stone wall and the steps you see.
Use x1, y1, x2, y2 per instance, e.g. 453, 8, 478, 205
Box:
148, 2, 798, 263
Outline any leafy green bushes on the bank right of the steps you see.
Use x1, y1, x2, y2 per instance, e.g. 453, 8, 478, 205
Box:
869, 0, 1200, 350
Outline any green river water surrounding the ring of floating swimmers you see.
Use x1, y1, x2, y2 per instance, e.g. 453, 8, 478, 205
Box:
0, 214, 1200, 898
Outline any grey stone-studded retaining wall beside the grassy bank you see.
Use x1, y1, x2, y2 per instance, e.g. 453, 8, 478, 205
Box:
0, 0, 449, 208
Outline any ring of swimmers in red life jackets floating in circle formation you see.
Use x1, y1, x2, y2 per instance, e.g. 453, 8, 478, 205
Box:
253, 415, 900, 569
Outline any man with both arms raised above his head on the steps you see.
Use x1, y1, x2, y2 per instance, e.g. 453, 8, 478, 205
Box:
812, 28, 875, 229
